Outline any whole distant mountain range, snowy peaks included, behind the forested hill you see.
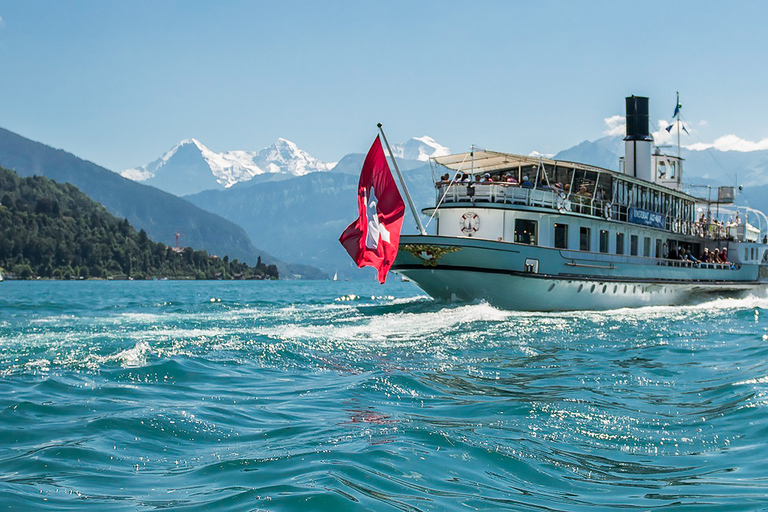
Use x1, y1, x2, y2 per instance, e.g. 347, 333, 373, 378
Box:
6, 123, 768, 279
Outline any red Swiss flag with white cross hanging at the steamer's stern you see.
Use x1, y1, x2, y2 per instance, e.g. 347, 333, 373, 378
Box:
339, 137, 405, 283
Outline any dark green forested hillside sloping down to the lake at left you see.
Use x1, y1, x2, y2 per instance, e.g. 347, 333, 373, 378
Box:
0, 168, 278, 279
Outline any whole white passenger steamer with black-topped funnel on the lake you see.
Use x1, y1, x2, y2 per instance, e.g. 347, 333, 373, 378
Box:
392, 96, 768, 311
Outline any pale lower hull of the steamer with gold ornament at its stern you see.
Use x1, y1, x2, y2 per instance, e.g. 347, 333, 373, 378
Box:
393, 235, 765, 311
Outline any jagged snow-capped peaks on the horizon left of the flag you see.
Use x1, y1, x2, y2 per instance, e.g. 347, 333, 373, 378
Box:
120, 139, 335, 196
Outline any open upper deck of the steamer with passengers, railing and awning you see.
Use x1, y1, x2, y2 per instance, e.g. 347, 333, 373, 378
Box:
433, 151, 768, 240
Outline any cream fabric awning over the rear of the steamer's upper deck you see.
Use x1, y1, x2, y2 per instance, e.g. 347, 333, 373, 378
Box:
432, 150, 613, 174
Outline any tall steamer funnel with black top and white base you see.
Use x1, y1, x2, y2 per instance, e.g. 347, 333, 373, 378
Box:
624, 96, 653, 181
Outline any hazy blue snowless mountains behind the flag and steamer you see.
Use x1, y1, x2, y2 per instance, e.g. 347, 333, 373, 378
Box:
180, 137, 768, 278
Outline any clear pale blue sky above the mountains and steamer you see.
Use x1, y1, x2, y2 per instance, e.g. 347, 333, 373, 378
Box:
0, 0, 768, 172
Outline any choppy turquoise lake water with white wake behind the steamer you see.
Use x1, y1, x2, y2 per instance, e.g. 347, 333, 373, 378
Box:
0, 281, 768, 511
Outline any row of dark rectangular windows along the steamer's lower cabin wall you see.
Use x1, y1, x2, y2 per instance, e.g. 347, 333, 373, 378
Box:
515, 219, 662, 258
